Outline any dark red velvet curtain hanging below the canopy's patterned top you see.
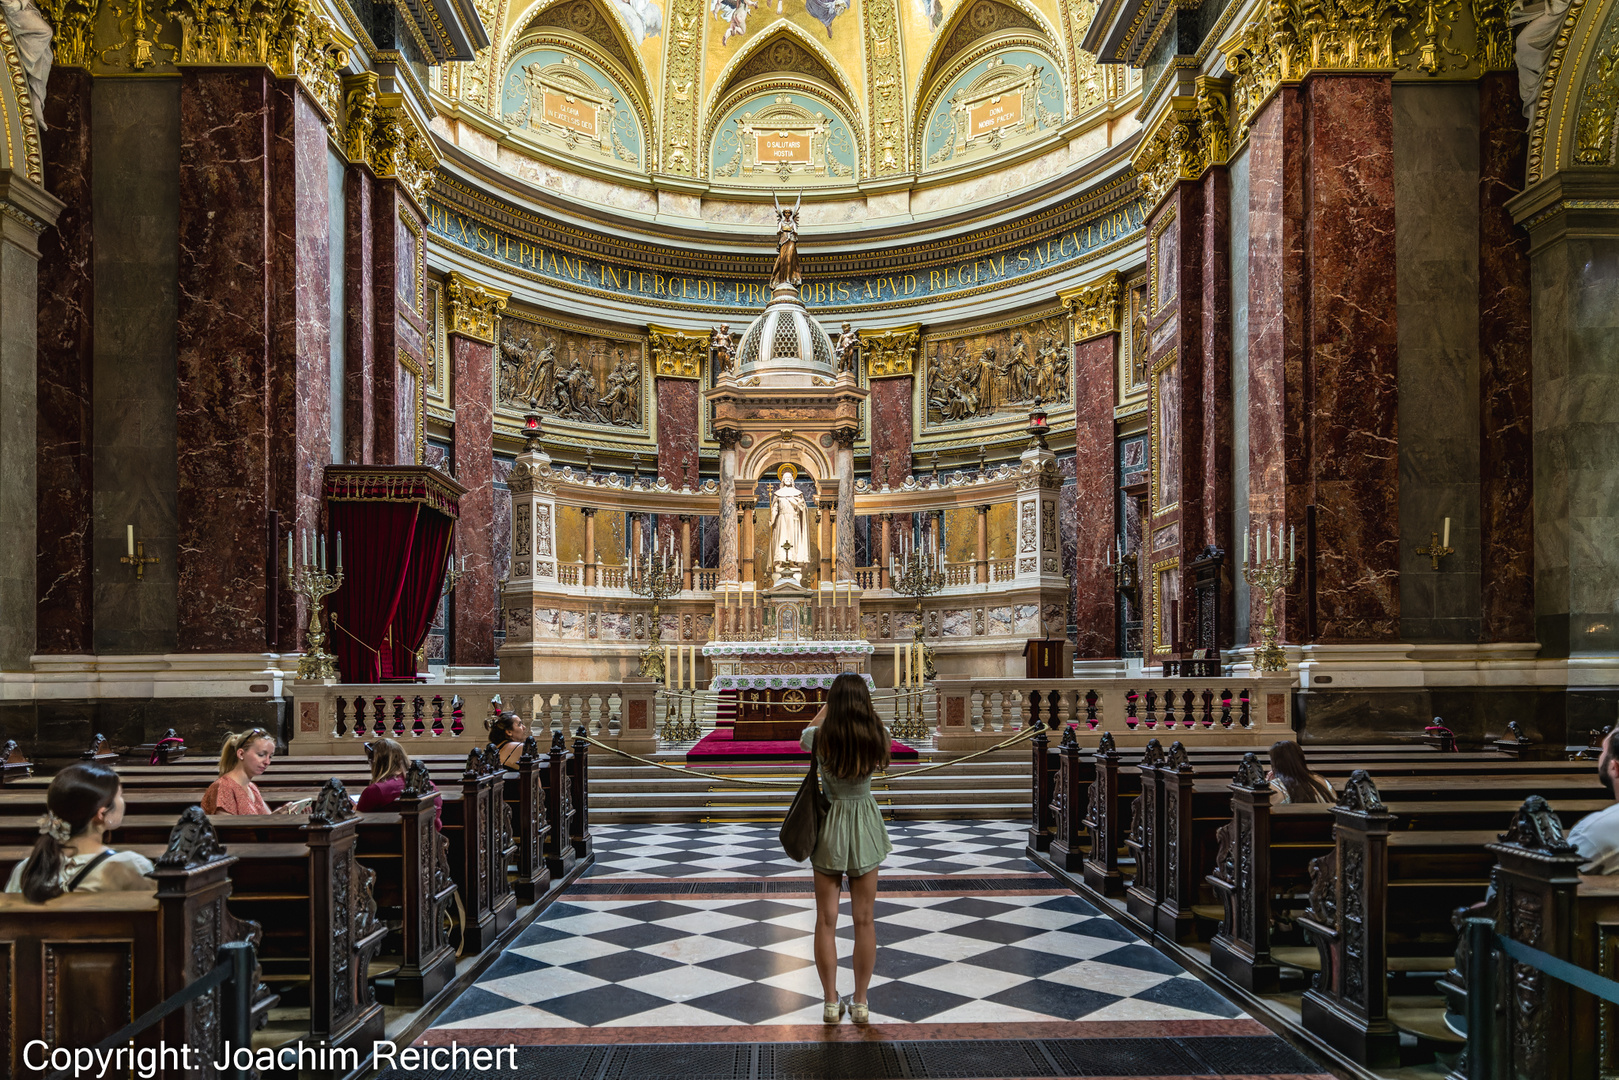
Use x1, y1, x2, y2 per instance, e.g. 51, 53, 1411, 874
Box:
327, 500, 417, 683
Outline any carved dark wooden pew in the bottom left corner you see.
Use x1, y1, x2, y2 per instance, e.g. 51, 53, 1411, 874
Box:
0, 811, 275, 1080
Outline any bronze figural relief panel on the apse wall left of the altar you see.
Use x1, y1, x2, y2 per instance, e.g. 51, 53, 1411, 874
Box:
495, 316, 646, 427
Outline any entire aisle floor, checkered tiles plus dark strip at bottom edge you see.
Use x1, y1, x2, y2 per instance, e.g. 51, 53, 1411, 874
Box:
395, 821, 1319, 1080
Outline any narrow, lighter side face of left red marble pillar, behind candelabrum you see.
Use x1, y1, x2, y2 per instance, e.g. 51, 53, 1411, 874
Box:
270, 79, 337, 651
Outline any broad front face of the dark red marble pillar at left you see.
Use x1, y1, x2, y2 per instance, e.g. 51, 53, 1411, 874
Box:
176, 68, 275, 653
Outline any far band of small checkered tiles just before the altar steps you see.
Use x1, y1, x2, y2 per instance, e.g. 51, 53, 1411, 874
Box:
591, 821, 1039, 879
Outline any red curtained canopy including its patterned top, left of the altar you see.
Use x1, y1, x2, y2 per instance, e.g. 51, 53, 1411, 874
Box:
324, 465, 466, 683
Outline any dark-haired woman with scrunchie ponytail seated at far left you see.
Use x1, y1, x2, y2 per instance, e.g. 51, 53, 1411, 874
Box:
5, 763, 157, 904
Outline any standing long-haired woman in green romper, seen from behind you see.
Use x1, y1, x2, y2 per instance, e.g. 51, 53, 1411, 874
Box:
798, 674, 894, 1023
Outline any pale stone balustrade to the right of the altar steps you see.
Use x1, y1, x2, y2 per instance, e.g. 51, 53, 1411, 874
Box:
934, 675, 1292, 738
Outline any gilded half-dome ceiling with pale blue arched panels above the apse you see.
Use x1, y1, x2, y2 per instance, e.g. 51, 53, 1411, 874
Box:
436, 0, 1138, 196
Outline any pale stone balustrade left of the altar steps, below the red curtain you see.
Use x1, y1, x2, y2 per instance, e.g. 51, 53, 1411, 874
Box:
290, 683, 623, 756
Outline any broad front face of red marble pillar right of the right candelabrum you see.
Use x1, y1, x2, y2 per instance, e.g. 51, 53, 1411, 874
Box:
1303, 74, 1400, 643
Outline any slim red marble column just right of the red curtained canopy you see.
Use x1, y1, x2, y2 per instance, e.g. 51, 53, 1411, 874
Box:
450, 334, 495, 665
